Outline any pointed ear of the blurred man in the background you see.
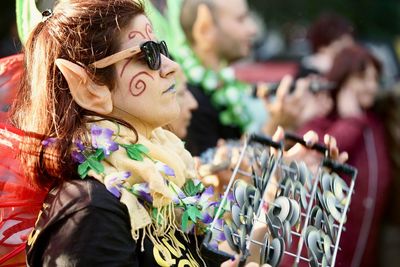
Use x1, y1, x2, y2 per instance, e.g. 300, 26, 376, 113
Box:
192, 4, 215, 50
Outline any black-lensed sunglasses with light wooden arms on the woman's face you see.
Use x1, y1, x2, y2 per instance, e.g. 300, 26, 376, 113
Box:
90, 41, 171, 70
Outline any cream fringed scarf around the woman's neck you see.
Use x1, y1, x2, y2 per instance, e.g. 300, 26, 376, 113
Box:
88, 118, 196, 240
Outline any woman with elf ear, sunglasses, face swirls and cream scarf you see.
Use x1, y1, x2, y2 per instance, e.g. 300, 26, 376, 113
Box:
3, 0, 346, 266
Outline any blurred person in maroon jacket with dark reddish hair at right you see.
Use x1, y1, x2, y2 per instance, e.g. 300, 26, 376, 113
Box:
299, 45, 391, 267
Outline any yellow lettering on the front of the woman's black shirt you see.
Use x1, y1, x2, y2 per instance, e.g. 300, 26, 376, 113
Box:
153, 233, 200, 267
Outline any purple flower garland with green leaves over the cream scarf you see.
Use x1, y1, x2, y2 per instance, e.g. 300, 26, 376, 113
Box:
70, 124, 230, 239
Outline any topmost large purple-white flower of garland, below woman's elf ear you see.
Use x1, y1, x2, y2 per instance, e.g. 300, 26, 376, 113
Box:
90, 124, 119, 156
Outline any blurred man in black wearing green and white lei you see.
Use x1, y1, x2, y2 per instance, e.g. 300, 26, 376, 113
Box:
177, 0, 266, 156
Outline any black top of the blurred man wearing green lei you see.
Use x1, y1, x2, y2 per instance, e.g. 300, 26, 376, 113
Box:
185, 84, 242, 156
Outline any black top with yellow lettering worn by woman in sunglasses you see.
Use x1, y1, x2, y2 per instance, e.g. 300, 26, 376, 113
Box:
27, 178, 214, 267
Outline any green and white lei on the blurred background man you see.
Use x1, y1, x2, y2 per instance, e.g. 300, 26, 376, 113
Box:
177, 44, 255, 131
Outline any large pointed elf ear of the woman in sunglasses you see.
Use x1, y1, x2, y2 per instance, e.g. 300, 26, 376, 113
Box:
55, 58, 113, 115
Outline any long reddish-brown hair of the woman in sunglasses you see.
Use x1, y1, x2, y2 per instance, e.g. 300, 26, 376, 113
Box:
11, 0, 144, 187
